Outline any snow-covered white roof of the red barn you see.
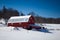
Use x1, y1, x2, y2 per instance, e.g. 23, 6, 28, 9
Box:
8, 15, 31, 23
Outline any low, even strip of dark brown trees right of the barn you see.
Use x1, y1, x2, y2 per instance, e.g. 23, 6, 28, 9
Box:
35, 16, 60, 24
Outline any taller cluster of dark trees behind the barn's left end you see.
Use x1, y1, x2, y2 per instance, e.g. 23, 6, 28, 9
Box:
0, 6, 19, 19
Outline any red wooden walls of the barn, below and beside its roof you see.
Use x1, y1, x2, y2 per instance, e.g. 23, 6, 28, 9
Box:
8, 16, 35, 27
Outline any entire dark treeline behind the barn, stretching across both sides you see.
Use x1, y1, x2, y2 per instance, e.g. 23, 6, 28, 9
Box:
0, 6, 60, 24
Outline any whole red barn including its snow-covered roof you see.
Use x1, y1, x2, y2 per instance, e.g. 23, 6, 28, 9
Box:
7, 15, 35, 28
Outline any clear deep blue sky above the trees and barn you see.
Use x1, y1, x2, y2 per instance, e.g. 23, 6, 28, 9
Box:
0, 0, 60, 18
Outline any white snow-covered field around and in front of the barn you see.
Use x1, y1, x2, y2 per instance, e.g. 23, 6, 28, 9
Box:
0, 24, 60, 40
